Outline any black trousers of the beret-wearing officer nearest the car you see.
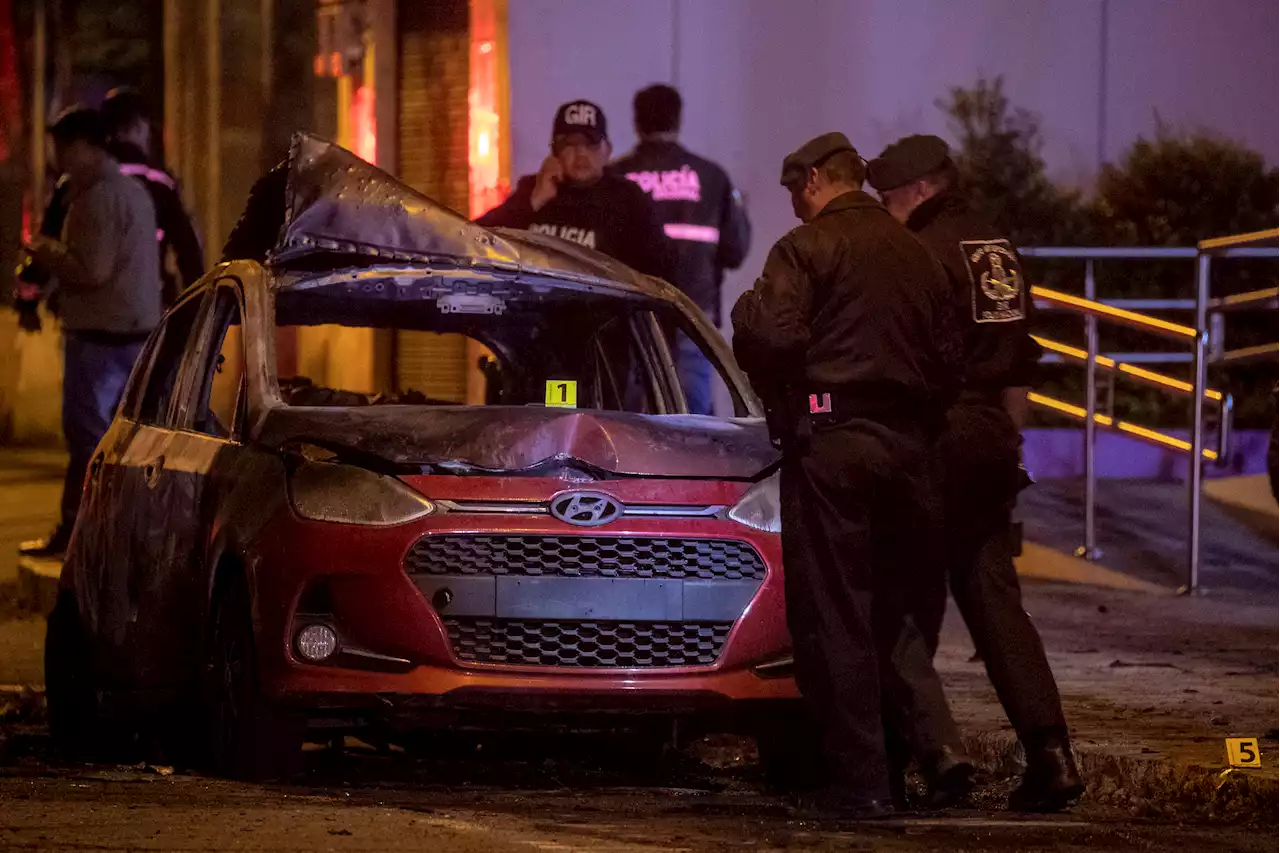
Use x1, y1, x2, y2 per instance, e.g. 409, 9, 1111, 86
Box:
782, 420, 959, 799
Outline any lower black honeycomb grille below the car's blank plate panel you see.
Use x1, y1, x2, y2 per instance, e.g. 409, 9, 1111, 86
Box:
444, 619, 733, 669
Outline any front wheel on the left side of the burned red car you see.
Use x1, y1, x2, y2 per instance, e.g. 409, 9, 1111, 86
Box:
201, 578, 303, 780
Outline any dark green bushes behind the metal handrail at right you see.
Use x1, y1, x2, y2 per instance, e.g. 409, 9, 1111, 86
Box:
938, 77, 1280, 428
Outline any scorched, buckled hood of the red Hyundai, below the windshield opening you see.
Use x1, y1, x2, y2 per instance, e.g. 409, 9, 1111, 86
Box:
259, 406, 778, 479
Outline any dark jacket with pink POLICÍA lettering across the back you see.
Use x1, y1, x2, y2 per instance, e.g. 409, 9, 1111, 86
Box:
611, 141, 751, 323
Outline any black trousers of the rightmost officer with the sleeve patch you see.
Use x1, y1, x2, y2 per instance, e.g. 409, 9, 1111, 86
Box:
920, 402, 1066, 748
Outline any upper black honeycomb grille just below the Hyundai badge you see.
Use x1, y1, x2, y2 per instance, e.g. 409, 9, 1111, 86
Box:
404, 534, 764, 580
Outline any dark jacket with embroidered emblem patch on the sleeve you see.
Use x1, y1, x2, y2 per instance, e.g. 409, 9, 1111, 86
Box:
906, 191, 1041, 397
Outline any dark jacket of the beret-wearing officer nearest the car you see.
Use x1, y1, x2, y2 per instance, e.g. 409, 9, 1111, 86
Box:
733, 192, 959, 420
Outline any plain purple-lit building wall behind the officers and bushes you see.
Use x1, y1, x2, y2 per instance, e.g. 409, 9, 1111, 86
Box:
509, 0, 1280, 325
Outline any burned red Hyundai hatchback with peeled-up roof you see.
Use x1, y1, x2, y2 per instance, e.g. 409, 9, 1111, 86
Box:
47, 137, 797, 775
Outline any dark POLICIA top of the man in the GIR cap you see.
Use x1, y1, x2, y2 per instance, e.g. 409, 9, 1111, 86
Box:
476, 174, 673, 280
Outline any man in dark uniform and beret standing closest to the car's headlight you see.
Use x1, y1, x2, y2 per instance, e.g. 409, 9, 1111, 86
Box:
732, 133, 973, 815
